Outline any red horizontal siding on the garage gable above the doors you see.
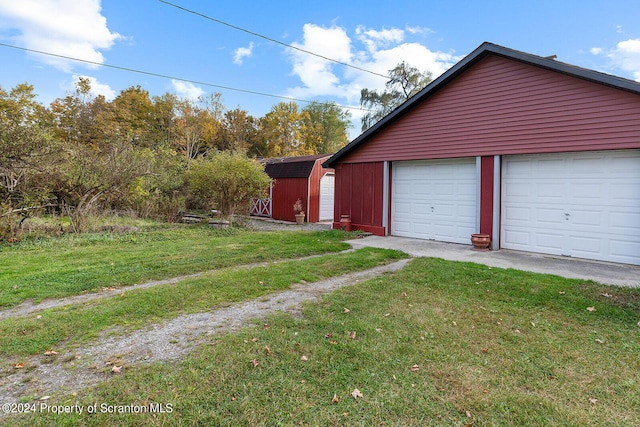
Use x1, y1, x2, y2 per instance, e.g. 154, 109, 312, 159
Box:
341, 55, 640, 163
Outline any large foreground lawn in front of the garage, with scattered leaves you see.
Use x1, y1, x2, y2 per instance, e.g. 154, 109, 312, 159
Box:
6, 259, 640, 426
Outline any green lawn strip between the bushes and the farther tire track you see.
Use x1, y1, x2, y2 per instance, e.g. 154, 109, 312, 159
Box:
0, 226, 349, 308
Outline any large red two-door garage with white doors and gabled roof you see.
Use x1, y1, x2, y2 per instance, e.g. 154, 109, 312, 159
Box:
325, 43, 640, 265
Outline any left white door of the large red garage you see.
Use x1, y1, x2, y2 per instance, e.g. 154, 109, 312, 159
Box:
391, 158, 477, 244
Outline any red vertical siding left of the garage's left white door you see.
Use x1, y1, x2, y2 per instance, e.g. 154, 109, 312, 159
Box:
334, 162, 385, 236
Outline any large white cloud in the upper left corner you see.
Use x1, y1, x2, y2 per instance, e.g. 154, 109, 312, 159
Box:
0, 0, 123, 71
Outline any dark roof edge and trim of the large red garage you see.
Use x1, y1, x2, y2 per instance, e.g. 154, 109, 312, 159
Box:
323, 42, 640, 168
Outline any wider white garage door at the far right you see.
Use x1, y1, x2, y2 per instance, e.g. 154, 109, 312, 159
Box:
500, 150, 640, 264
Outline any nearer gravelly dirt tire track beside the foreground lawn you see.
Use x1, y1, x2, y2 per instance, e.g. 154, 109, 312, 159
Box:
0, 259, 410, 403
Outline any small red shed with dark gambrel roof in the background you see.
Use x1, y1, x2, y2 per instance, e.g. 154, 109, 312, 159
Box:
251, 154, 335, 222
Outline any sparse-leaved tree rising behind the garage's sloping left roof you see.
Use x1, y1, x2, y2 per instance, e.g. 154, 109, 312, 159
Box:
360, 61, 431, 132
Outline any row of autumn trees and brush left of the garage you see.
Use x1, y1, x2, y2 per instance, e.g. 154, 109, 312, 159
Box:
0, 78, 350, 236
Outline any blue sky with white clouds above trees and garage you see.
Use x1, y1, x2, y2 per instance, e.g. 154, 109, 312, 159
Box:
0, 0, 640, 138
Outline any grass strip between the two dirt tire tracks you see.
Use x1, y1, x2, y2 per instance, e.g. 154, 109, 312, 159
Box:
0, 248, 406, 359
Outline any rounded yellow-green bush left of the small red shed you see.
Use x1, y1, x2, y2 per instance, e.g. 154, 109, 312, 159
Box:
186, 151, 271, 221
